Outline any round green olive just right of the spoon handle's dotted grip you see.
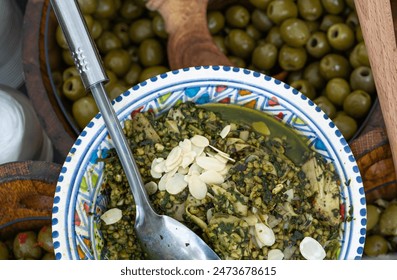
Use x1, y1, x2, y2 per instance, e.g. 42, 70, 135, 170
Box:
103, 49, 131, 77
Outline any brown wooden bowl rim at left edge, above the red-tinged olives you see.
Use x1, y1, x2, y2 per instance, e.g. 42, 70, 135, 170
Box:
0, 161, 61, 239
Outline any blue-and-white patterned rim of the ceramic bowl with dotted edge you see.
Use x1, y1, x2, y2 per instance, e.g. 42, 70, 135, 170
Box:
52, 66, 367, 260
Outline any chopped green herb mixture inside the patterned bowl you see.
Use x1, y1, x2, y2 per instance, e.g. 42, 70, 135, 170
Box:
99, 103, 341, 260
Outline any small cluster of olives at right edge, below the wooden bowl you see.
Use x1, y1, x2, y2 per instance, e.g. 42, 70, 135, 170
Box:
364, 199, 397, 257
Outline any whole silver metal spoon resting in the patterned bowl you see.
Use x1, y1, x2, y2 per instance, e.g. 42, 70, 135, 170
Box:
51, 0, 219, 260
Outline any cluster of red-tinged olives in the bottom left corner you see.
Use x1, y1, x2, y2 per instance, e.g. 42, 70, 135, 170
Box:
0, 226, 55, 260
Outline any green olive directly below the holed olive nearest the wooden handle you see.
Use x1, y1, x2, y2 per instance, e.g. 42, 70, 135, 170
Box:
320, 53, 351, 80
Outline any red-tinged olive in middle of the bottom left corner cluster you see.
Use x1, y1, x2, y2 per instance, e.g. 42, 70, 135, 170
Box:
12, 231, 42, 260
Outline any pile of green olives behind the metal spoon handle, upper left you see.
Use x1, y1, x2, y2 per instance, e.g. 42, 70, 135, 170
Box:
52, 0, 169, 129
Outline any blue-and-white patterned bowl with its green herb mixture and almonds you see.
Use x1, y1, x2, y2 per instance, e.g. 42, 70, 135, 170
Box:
52, 66, 366, 259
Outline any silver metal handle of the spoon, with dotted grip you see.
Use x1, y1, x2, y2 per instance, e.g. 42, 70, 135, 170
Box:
51, 0, 154, 219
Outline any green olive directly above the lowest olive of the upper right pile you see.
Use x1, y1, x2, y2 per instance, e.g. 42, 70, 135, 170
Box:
343, 90, 372, 119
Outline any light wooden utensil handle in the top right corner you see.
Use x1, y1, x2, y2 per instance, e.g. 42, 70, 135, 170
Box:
355, 0, 397, 179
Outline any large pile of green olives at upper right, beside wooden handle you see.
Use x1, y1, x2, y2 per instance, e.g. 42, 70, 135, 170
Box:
208, 0, 376, 140
